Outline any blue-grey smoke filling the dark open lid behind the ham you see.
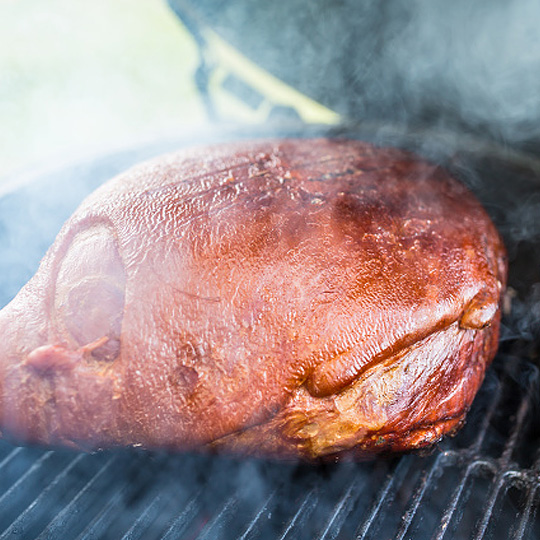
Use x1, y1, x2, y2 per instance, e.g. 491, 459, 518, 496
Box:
182, 0, 540, 150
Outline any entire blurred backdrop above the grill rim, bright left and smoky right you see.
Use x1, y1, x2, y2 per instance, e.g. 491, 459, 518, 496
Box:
5, 0, 540, 186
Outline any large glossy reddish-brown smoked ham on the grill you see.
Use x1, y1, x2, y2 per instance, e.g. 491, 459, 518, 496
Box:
0, 139, 506, 459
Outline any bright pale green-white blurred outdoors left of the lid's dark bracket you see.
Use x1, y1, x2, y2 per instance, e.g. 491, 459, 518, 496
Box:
0, 0, 206, 179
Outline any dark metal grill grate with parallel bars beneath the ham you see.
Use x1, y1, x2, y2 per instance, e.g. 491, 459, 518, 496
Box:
0, 353, 540, 540
